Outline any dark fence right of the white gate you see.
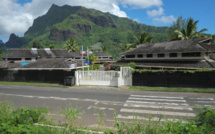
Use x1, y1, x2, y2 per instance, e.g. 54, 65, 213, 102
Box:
132, 71, 215, 88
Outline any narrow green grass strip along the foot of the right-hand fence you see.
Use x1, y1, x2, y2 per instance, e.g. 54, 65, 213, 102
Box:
130, 86, 215, 93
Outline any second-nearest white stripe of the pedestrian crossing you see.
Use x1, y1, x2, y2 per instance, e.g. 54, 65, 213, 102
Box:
120, 108, 195, 117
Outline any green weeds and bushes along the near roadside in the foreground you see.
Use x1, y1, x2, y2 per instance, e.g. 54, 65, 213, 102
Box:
0, 100, 215, 134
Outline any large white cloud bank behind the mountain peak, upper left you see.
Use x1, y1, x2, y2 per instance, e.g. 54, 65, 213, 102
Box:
0, 0, 127, 38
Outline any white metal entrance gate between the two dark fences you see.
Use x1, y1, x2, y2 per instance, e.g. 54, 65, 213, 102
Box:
75, 67, 132, 87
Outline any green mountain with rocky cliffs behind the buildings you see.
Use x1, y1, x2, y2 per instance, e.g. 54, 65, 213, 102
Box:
6, 5, 169, 55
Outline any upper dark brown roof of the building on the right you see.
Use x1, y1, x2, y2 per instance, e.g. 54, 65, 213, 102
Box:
121, 38, 210, 55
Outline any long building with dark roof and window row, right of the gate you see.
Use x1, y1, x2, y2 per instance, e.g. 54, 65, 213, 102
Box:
112, 38, 215, 69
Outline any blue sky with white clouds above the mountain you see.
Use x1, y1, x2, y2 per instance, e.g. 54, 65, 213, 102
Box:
0, 0, 215, 42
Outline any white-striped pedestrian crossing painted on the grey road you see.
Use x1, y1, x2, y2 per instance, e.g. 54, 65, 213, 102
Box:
117, 95, 215, 122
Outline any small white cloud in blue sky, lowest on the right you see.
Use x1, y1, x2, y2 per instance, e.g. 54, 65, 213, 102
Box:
153, 15, 177, 24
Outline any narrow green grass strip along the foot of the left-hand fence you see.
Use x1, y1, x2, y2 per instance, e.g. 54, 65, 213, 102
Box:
0, 81, 63, 87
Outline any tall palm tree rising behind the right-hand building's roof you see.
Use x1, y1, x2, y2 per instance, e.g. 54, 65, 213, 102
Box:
175, 18, 207, 40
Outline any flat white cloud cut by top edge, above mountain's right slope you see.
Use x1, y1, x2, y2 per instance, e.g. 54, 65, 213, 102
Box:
119, 0, 163, 9
